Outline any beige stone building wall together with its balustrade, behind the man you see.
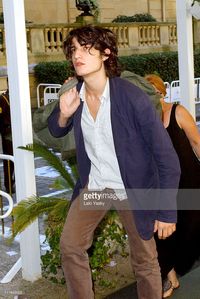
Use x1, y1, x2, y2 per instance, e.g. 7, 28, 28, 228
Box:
0, 0, 182, 107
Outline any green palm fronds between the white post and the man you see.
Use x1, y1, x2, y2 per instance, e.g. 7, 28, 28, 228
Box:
12, 143, 77, 238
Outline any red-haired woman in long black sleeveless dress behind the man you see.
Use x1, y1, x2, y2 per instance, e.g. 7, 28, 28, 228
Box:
145, 74, 200, 298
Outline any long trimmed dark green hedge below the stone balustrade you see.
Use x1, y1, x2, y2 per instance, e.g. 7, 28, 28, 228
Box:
35, 52, 200, 84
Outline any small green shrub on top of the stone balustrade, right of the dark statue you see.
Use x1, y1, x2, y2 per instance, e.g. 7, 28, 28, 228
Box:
112, 13, 157, 23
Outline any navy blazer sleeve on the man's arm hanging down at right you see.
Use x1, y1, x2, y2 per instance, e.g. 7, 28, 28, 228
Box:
128, 90, 181, 222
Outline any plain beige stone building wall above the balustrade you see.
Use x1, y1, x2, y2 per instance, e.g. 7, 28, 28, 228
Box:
0, 0, 176, 24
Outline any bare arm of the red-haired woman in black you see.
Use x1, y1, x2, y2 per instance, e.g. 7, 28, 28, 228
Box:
176, 105, 200, 159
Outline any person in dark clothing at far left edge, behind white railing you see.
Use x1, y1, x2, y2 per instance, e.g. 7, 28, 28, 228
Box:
0, 84, 15, 194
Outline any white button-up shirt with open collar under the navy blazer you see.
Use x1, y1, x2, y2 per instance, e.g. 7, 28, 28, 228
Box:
80, 79, 126, 199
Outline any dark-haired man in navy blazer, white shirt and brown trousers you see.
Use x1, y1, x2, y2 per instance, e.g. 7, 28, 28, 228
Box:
48, 25, 180, 299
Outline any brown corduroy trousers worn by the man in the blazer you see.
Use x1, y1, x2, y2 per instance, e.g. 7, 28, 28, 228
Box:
60, 191, 162, 299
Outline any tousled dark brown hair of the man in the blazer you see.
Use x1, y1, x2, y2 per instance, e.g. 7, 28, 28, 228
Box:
63, 25, 121, 77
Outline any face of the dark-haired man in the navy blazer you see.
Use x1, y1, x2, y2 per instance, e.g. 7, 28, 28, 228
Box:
72, 38, 105, 77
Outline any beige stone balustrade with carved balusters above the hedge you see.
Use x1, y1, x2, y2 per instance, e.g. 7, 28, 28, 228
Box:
0, 23, 180, 65
